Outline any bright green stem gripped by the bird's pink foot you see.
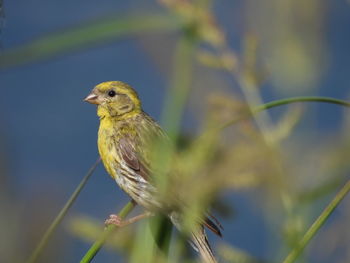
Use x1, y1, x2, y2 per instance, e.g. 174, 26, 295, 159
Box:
80, 200, 136, 263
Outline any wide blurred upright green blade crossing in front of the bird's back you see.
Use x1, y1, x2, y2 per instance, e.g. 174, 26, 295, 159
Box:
126, 20, 197, 262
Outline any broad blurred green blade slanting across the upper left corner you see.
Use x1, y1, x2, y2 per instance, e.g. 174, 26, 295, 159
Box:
0, 14, 181, 69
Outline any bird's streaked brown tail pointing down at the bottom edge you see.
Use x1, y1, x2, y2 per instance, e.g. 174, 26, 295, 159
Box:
191, 226, 217, 263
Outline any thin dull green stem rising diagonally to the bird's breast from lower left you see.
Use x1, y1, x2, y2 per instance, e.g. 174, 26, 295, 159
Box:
26, 158, 101, 263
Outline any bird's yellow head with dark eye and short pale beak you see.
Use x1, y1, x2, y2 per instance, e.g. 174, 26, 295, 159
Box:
84, 81, 141, 117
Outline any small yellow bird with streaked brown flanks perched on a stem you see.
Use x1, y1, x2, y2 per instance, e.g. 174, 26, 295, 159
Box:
84, 81, 222, 263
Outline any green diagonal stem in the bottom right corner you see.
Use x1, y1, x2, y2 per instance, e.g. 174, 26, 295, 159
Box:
283, 180, 350, 263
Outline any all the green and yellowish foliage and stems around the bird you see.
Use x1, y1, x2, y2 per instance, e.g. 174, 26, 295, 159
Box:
0, 0, 350, 263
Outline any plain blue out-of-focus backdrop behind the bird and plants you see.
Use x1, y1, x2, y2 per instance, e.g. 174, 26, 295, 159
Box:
0, 0, 350, 262
